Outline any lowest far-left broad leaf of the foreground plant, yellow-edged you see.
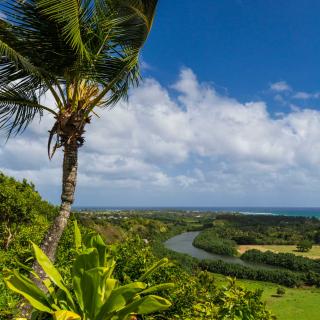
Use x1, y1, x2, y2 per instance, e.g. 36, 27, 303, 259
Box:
5, 271, 52, 313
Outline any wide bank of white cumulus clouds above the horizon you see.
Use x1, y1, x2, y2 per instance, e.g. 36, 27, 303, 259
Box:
0, 68, 320, 205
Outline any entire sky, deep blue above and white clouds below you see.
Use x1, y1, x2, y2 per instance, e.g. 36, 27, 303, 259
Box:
0, 0, 320, 206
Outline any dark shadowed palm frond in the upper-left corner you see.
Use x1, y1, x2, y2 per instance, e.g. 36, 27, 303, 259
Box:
0, 0, 78, 82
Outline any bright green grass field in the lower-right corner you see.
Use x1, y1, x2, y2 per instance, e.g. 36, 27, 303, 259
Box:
215, 274, 320, 320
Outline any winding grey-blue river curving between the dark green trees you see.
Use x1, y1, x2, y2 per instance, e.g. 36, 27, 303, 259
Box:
164, 231, 275, 270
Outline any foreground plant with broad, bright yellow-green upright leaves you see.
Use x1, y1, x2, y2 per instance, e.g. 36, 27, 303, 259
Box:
5, 223, 173, 320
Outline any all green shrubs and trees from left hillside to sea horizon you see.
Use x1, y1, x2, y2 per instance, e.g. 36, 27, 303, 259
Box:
0, 175, 320, 320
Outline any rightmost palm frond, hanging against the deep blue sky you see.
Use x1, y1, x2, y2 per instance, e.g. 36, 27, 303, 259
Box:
83, 0, 157, 110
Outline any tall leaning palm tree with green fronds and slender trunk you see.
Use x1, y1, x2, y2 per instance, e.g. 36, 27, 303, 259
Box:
0, 0, 157, 264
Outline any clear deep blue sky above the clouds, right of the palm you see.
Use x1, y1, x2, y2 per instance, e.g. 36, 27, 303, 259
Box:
144, 0, 320, 107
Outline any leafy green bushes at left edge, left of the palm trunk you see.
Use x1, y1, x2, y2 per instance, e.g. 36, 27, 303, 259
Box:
0, 173, 57, 320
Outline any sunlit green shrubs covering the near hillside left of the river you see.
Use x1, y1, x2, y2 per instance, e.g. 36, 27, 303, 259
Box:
0, 174, 273, 320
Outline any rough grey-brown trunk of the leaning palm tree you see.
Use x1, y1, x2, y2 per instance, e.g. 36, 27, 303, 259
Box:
33, 141, 78, 279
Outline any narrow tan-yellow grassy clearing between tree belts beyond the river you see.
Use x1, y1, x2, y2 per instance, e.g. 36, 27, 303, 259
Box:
238, 245, 320, 259
